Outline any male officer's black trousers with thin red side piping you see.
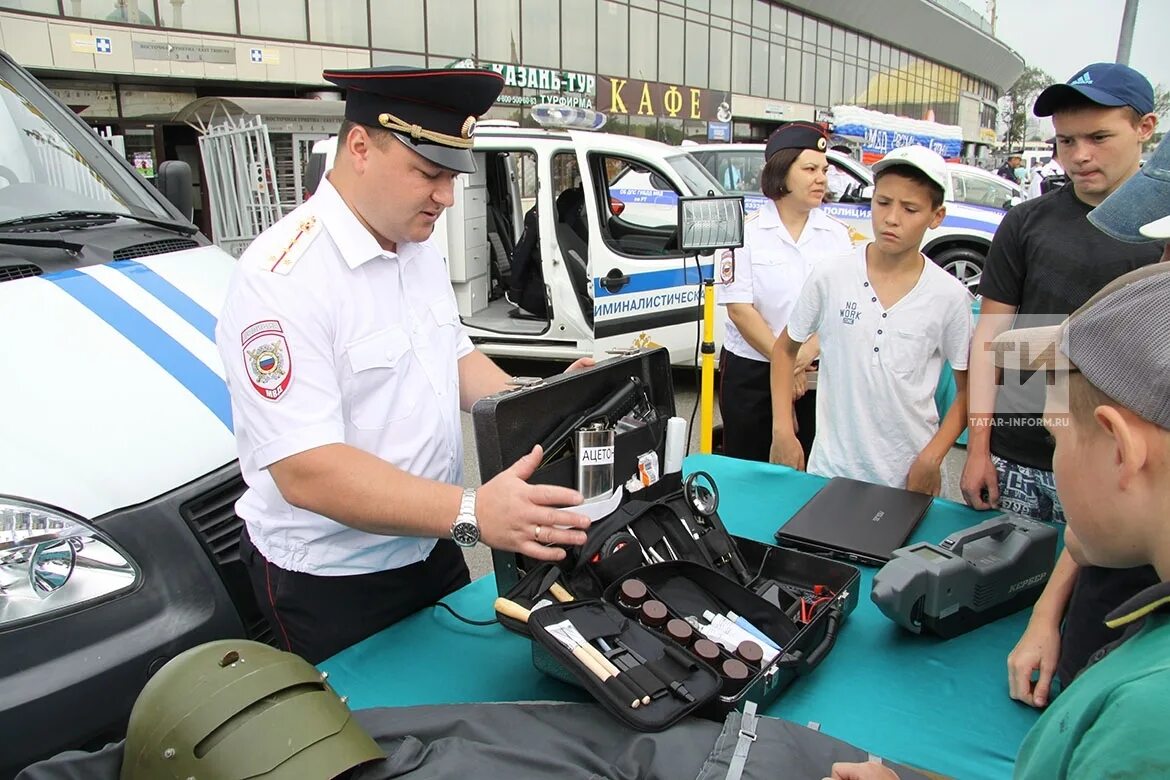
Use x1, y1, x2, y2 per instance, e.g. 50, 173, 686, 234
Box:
240, 531, 472, 663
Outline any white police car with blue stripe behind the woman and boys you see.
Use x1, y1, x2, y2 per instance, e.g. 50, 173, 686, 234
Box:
684, 144, 1021, 292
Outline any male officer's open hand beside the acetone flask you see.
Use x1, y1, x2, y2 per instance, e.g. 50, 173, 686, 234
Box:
475, 446, 590, 560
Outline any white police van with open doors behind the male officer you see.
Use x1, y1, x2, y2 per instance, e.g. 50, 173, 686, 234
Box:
308, 120, 723, 366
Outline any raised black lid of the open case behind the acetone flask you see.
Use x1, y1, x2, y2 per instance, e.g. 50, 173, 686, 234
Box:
472, 347, 674, 484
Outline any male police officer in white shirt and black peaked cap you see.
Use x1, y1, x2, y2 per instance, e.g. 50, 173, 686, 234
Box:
215, 68, 591, 663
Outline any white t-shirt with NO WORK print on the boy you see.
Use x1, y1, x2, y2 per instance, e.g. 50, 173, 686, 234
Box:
789, 247, 972, 488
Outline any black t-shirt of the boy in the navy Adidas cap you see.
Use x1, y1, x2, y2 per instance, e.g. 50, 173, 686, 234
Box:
979, 185, 1162, 471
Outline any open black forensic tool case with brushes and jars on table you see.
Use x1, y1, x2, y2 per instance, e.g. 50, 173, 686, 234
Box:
472, 350, 859, 731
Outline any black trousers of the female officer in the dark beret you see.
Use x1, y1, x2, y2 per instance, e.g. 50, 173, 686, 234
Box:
720, 350, 817, 463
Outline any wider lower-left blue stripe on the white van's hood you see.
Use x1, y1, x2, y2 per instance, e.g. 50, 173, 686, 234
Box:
41, 270, 232, 430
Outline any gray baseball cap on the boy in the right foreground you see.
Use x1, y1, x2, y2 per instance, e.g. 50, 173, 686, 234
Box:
992, 263, 1170, 429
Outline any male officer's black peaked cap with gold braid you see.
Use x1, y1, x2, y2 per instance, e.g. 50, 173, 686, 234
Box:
322, 65, 504, 173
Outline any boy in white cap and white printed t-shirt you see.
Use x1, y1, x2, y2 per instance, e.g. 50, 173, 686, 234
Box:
771, 146, 972, 496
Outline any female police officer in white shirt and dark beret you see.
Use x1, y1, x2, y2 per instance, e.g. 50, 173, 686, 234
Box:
717, 122, 852, 462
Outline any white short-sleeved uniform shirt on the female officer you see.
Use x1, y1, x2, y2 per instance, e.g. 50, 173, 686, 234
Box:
716, 200, 853, 363
